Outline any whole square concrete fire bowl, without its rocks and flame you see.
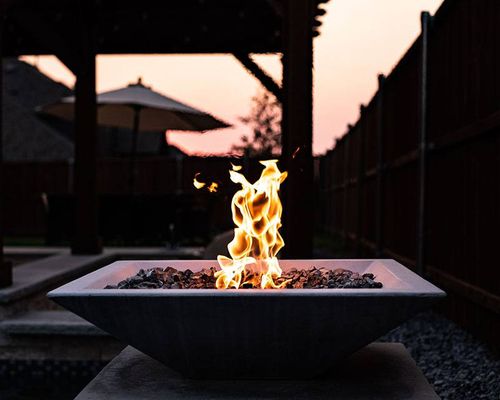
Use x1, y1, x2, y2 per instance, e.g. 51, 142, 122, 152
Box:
48, 260, 445, 378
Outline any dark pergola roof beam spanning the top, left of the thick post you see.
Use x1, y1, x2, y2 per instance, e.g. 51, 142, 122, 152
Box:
2, 0, 290, 56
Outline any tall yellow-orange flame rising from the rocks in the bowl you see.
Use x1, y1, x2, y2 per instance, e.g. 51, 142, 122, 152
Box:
215, 160, 287, 289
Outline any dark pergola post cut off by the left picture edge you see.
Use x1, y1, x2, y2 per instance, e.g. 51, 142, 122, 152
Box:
0, 7, 12, 287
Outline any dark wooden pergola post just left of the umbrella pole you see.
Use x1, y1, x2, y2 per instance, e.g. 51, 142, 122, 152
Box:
71, 10, 102, 254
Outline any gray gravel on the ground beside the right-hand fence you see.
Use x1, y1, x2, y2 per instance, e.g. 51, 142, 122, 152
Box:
381, 312, 500, 400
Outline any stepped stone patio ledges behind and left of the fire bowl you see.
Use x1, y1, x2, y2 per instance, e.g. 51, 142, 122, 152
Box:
0, 247, 201, 368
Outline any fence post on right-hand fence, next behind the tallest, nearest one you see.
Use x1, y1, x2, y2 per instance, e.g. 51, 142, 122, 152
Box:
375, 74, 385, 257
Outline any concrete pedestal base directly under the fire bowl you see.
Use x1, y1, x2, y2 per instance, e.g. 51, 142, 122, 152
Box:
76, 343, 439, 400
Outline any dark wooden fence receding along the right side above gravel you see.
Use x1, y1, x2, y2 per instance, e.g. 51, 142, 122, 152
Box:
317, 0, 500, 348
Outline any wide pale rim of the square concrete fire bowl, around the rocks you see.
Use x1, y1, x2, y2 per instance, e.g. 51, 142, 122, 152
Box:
47, 259, 446, 298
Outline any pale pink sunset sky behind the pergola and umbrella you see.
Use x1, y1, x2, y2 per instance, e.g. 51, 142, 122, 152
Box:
23, 0, 443, 155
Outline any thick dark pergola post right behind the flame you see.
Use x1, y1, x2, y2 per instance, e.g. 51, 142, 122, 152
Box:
282, 0, 314, 258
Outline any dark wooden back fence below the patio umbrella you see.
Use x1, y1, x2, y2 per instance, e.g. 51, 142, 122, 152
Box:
3, 157, 261, 244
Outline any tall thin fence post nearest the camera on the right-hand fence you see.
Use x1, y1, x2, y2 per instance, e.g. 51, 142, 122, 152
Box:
416, 11, 431, 275
